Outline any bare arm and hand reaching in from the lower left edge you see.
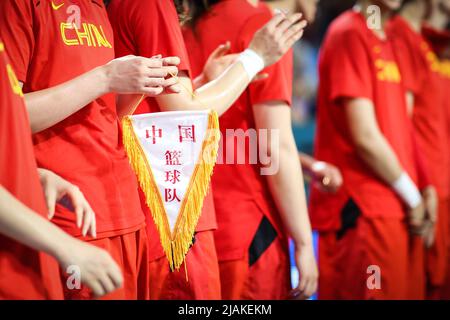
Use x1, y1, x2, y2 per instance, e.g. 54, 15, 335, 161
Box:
0, 186, 123, 296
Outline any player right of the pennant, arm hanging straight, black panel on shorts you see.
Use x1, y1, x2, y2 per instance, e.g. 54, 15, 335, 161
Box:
185, 0, 317, 299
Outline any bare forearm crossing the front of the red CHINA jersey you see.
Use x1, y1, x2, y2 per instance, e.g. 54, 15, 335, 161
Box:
25, 67, 108, 133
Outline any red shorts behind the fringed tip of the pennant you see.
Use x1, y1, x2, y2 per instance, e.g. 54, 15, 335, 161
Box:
149, 231, 221, 300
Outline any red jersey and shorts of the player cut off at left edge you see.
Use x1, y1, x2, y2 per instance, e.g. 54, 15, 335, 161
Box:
0, 40, 62, 299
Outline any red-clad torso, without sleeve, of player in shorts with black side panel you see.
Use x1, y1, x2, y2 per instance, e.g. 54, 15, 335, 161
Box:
184, 0, 286, 260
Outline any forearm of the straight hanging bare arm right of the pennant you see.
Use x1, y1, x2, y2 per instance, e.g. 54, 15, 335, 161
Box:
267, 141, 312, 247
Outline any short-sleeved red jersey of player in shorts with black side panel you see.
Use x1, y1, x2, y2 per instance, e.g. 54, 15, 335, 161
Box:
185, 0, 293, 261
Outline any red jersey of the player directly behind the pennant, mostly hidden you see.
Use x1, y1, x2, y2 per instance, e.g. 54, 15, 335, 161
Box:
108, 0, 217, 260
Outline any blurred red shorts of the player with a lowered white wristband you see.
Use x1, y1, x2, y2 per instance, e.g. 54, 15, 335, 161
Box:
319, 216, 412, 300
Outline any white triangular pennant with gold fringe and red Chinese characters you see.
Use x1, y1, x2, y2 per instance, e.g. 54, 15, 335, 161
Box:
122, 110, 220, 270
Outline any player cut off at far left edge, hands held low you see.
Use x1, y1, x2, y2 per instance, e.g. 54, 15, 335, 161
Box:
0, 40, 123, 299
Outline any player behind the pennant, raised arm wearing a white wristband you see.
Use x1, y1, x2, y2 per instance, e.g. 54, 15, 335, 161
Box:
108, 0, 304, 299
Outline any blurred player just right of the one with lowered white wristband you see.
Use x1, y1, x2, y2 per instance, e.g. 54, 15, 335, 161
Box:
389, 0, 450, 298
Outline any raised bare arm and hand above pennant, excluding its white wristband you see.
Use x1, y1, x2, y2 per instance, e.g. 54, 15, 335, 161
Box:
142, 14, 306, 115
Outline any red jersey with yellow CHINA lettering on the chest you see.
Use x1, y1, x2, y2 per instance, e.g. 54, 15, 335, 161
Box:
0, 0, 144, 238
